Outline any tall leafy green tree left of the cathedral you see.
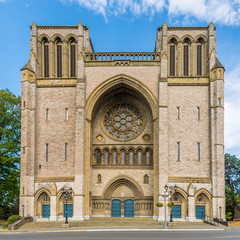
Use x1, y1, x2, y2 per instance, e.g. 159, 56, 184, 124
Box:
0, 89, 21, 219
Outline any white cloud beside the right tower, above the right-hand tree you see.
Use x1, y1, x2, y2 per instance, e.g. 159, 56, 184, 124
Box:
225, 63, 240, 156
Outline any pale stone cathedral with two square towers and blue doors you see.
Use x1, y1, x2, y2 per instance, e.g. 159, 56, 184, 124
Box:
20, 22, 225, 221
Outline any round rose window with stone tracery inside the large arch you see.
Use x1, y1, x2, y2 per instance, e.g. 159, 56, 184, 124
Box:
102, 103, 146, 141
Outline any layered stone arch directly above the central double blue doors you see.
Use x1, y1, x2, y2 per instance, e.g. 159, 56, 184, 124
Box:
102, 175, 144, 199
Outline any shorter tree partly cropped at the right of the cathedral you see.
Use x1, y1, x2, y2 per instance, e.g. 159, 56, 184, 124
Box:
225, 153, 240, 218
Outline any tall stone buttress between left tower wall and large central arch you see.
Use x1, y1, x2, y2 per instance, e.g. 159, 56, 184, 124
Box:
73, 22, 86, 221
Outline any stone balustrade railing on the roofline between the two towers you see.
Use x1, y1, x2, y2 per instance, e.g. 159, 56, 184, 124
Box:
85, 52, 160, 61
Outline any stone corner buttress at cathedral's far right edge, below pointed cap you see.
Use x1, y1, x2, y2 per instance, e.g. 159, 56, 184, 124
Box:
210, 65, 225, 219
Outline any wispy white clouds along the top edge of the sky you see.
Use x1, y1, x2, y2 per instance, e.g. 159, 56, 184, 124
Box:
62, 0, 240, 25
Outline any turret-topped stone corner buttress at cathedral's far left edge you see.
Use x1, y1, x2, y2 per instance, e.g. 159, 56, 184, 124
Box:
19, 68, 36, 217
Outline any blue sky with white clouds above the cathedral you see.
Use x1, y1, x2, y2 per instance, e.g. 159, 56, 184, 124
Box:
0, 0, 240, 158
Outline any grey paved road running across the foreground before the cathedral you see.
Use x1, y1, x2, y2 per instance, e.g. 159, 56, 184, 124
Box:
0, 230, 240, 240
